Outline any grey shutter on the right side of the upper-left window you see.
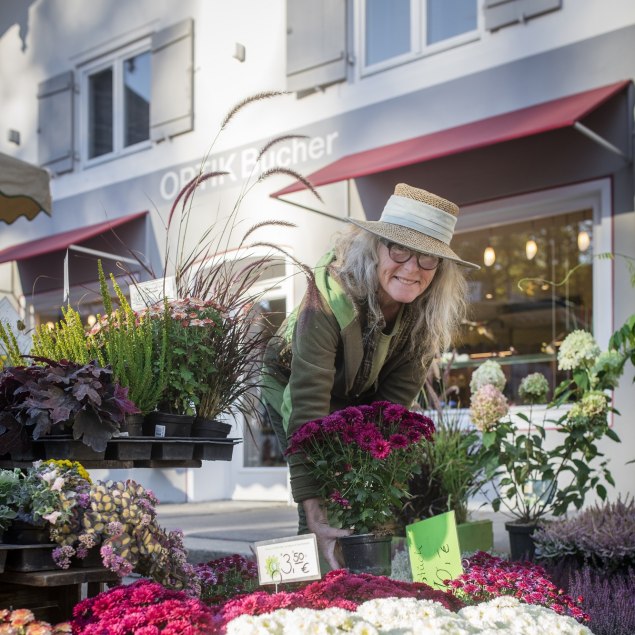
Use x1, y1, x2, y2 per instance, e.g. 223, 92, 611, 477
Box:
150, 19, 194, 141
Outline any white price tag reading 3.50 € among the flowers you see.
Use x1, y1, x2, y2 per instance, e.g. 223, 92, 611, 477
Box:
254, 534, 322, 585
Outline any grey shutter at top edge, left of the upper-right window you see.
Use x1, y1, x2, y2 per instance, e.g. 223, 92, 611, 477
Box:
287, 0, 346, 91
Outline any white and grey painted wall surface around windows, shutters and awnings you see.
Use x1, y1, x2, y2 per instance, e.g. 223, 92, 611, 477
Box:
0, 0, 635, 501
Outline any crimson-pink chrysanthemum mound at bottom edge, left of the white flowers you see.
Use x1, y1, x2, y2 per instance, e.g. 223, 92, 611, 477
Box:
71, 580, 213, 635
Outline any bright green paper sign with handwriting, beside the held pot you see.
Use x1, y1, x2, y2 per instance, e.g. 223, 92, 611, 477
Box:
406, 511, 463, 590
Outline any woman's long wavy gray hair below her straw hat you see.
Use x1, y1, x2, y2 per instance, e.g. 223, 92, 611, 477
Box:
333, 226, 467, 366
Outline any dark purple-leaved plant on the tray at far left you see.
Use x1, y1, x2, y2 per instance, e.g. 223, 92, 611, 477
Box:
0, 358, 137, 458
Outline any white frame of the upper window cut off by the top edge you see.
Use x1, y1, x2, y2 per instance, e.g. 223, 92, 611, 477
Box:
357, 0, 483, 77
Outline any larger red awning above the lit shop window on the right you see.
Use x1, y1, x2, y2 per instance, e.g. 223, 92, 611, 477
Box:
271, 81, 630, 198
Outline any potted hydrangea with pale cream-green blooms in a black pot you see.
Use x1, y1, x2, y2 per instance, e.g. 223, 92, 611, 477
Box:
471, 331, 623, 558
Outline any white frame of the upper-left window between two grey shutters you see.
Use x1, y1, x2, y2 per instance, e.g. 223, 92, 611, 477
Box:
78, 37, 152, 168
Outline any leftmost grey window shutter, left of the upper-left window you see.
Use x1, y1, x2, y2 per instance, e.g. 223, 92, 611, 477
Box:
37, 71, 75, 174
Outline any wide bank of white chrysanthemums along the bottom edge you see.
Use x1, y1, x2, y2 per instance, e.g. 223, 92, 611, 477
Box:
227, 597, 593, 635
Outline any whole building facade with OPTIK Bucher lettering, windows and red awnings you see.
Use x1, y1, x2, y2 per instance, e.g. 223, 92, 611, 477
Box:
0, 0, 635, 502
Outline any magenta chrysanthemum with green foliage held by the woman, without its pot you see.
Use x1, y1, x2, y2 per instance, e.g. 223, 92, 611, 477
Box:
287, 401, 434, 534
